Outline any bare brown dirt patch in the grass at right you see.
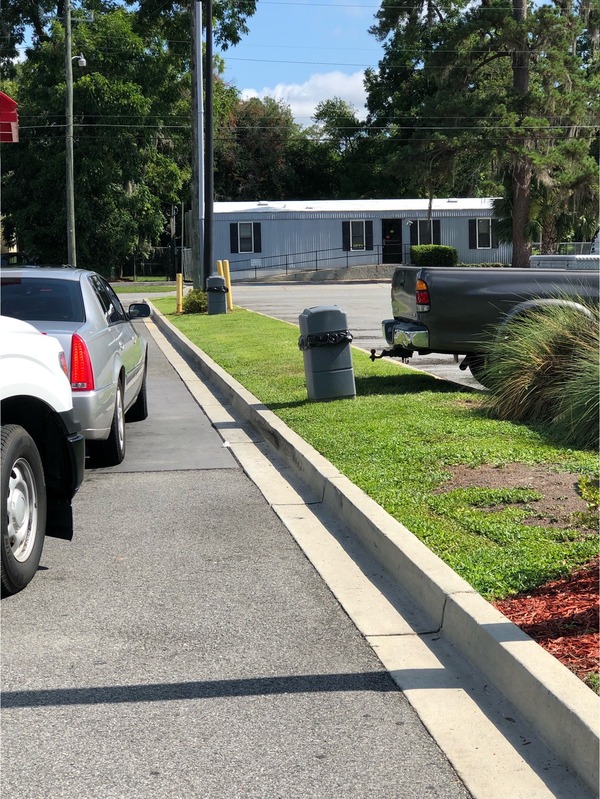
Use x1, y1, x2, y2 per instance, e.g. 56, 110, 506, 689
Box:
443, 463, 589, 532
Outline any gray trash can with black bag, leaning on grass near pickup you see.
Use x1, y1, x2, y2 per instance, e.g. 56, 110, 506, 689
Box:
298, 305, 356, 400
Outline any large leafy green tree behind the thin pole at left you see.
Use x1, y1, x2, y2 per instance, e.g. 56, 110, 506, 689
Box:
2, 8, 189, 273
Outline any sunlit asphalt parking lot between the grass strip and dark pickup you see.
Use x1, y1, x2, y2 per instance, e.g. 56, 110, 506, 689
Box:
232, 280, 482, 389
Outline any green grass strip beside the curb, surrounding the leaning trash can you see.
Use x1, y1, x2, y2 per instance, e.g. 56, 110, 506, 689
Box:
154, 298, 598, 599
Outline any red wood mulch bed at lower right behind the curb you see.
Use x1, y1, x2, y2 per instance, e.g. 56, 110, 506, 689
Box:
494, 559, 600, 680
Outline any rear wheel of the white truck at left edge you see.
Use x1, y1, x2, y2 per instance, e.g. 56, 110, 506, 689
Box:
1, 424, 46, 596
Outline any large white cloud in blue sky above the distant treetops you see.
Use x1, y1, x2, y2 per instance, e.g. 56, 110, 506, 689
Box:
241, 71, 366, 127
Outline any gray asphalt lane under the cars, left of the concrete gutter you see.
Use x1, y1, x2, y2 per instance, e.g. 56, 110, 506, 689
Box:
0, 324, 469, 799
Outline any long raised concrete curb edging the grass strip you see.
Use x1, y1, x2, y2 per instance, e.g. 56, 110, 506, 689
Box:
153, 306, 600, 792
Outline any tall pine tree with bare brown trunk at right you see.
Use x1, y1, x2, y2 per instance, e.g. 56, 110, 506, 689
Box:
367, 0, 600, 266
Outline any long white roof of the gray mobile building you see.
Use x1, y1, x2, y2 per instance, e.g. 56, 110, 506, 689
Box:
214, 197, 493, 214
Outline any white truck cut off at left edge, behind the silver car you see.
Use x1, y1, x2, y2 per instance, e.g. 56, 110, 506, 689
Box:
0, 316, 85, 595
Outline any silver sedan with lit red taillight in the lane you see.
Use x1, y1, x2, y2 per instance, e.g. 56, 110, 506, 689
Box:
0, 266, 151, 466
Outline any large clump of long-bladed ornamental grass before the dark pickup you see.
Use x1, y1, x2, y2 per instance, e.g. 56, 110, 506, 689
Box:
482, 302, 600, 449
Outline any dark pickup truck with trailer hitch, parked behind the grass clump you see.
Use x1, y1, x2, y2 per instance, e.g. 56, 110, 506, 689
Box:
371, 266, 599, 379
